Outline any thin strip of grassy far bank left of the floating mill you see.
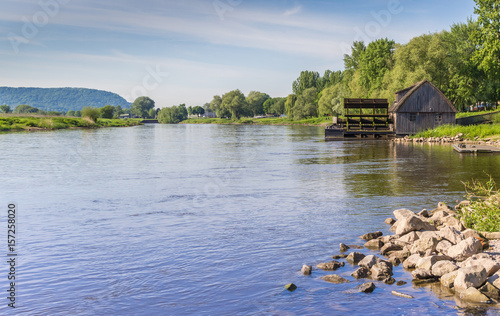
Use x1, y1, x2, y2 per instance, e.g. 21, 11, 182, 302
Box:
181, 117, 331, 126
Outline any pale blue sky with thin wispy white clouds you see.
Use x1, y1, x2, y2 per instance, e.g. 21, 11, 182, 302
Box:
0, 0, 474, 108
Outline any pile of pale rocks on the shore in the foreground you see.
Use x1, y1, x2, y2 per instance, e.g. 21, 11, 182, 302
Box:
294, 201, 500, 306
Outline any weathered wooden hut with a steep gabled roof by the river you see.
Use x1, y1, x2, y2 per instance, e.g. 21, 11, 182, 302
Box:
389, 80, 457, 136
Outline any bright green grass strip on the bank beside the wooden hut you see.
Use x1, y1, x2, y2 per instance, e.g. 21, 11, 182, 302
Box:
413, 124, 500, 140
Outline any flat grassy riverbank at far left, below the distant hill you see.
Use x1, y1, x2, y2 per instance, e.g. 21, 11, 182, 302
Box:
0, 115, 141, 131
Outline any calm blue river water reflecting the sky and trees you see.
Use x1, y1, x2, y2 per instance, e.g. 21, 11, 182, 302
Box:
0, 125, 500, 315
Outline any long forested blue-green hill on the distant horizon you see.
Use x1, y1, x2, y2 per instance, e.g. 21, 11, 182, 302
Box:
0, 87, 130, 112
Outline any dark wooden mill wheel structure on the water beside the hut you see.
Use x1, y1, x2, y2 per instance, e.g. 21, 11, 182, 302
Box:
325, 99, 394, 140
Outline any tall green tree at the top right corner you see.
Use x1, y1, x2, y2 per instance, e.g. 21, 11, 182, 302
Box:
471, 0, 500, 78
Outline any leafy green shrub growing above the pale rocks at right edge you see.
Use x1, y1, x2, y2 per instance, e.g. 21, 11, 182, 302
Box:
458, 176, 500, 232
